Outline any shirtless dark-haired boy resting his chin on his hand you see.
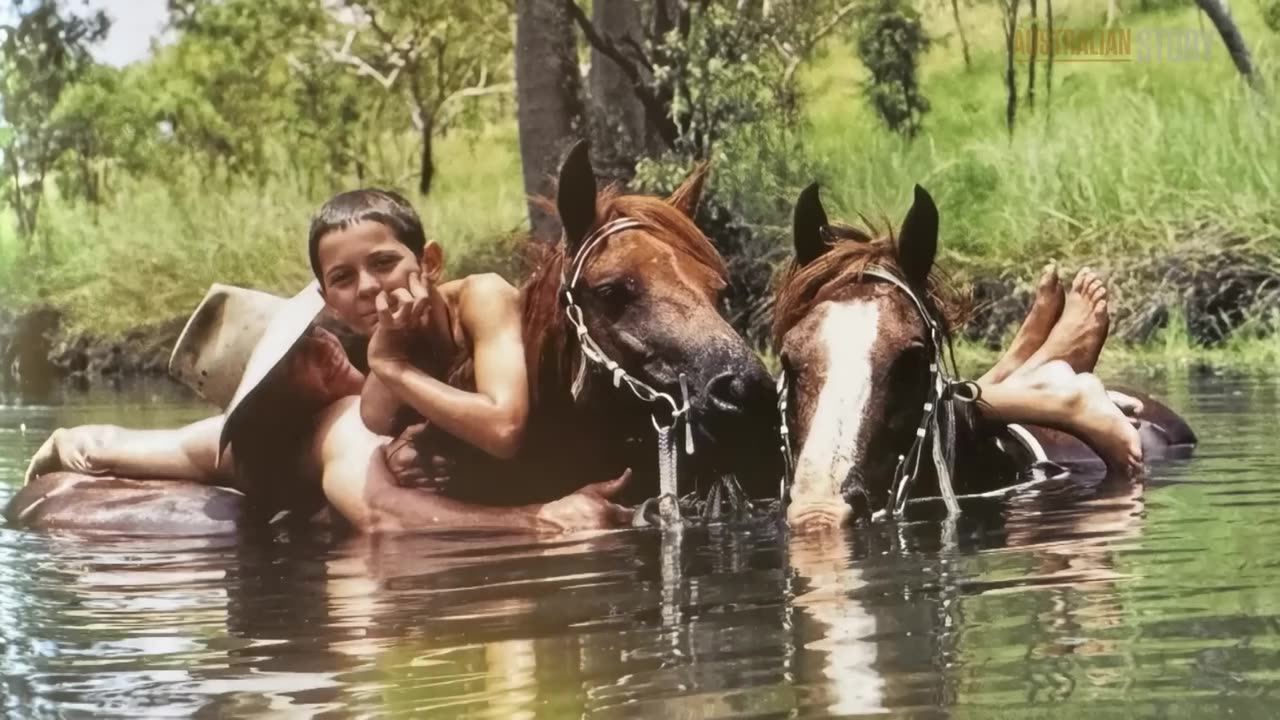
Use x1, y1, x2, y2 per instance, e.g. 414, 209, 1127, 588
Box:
308, 188, 529, 459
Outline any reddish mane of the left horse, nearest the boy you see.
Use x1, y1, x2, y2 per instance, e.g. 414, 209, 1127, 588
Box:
520, 167, 728, 402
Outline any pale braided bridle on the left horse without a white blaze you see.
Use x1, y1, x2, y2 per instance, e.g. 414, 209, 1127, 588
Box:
559, 217, 694, 528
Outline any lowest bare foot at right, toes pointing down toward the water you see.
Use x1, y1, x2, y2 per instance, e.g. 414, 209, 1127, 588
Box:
1062, 373, 1142, 478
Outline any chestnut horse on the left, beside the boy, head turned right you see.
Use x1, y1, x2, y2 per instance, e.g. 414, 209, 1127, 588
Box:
6, 143, 782, 534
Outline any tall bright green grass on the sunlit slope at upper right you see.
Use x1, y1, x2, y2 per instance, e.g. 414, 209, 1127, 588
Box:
806, 4, 1280, 272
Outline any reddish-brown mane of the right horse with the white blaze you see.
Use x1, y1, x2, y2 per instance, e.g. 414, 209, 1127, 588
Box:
773, 220, 968, 347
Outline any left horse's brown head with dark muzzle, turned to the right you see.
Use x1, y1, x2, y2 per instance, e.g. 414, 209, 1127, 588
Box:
527, 143, 781, 496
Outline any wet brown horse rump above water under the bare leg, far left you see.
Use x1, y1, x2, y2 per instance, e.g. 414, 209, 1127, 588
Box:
4, 473, 246, 537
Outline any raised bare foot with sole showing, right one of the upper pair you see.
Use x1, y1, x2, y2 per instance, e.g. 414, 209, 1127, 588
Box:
1012, 268, 1111, 375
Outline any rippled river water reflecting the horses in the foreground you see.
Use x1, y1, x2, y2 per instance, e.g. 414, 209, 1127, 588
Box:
0, 372, 1280, 719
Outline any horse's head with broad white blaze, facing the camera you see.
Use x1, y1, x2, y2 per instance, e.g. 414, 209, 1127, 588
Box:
773, 184, 945, 524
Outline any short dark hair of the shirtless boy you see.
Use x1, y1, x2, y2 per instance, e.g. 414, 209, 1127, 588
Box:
307, 187, 426, 280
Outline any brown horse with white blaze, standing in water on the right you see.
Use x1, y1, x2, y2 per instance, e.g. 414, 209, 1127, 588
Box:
773, 184, 1196, 518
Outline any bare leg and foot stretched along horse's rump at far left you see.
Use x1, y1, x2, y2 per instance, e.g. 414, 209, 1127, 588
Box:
26, 415, 232, 484
